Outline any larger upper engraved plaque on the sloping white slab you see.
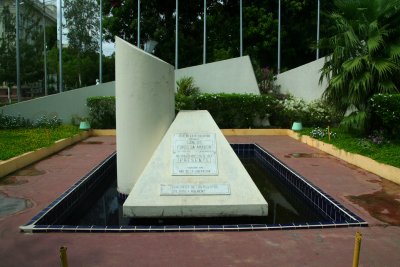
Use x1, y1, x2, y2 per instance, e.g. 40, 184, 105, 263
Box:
172, 133, 218, 176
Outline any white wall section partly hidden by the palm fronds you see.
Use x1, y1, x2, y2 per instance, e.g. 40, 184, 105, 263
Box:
275, 58, 327, 102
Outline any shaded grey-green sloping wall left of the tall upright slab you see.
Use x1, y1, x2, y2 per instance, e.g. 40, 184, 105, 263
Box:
0, 82, 115, 124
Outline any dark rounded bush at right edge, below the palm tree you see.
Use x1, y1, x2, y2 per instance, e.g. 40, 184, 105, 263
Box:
369, 94, 400, 136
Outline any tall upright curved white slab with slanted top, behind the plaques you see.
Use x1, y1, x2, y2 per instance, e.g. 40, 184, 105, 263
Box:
115, 37, 175, 195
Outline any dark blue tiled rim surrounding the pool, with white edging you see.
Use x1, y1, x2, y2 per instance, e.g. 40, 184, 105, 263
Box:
21, 144, 368, 233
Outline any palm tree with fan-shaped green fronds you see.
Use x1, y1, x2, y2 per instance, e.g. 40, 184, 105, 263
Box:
320, 0, 400, 129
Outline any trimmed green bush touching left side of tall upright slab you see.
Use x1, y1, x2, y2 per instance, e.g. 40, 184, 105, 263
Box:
86, 96, 116, 129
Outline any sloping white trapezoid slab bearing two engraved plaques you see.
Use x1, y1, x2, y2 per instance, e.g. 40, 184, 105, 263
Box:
123, 111, 268, 217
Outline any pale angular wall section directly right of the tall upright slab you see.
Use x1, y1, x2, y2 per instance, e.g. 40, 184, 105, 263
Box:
175, 56, 260, 94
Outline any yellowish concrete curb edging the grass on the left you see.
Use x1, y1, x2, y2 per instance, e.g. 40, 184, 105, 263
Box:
0, 131, 91, 178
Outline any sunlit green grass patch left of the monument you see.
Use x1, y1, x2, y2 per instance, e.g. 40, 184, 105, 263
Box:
0, 125, 80, 160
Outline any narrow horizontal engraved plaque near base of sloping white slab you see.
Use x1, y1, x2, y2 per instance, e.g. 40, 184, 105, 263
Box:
160, 184, 231, 196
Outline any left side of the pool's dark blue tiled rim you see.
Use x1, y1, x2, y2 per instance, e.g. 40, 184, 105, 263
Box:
21, 152, 116, 228
